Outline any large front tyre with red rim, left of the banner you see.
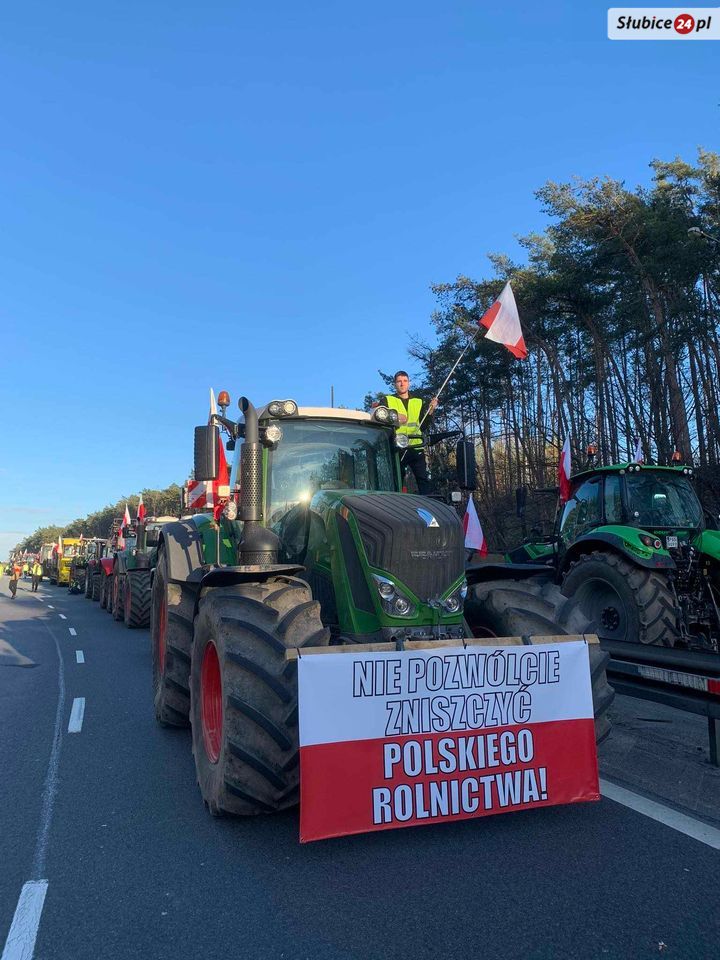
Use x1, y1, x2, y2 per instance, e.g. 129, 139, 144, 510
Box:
190, 577, 330, 816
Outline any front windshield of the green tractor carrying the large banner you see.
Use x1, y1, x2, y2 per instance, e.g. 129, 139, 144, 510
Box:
268, 420, 397, 523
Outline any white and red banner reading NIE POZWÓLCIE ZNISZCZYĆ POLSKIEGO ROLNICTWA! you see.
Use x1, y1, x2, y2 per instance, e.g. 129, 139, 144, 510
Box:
298, 641, 600, 843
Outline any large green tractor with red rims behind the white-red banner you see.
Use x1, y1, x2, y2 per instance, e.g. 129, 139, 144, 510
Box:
151, 394, 613, 815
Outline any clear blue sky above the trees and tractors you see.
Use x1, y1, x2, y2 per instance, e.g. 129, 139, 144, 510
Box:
0, 0, 720, 557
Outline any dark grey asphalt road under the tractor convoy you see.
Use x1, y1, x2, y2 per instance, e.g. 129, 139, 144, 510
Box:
0, 578, 720, 960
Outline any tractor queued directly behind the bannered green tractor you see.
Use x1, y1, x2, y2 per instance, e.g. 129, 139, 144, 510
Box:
106, 517, 176, 629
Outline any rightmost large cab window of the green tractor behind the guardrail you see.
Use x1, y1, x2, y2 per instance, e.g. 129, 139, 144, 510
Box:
625, 471, 702, 530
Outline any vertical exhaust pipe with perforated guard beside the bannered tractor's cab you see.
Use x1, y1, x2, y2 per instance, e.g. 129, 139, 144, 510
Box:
238, 397, 280, 566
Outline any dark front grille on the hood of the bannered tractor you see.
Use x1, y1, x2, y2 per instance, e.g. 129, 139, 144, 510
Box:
343, 493, 465, 600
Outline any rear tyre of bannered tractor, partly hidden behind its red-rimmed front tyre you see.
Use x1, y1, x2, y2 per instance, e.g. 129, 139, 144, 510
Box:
150, 550, 194, 727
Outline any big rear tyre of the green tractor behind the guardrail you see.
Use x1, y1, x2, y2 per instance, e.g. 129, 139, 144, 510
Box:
562, 550, 680, 647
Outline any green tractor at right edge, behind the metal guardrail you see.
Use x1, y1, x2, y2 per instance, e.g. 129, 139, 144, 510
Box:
507, 463, 720, 653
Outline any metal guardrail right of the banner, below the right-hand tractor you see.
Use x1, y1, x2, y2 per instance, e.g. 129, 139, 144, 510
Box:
601, 640, 720, 767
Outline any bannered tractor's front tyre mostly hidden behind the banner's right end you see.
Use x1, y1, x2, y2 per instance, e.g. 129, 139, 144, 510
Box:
465, 578, 615, 743
